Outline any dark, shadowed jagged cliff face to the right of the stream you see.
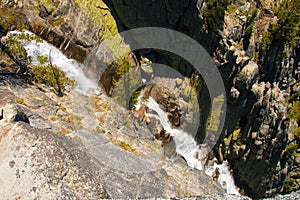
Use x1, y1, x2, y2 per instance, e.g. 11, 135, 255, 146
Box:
112, 0, 299, 198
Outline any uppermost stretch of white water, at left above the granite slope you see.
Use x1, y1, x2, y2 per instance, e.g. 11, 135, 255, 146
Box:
11, 31, 98, 94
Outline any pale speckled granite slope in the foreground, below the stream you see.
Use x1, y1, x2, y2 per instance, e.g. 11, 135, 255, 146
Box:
0, 74, 225, 199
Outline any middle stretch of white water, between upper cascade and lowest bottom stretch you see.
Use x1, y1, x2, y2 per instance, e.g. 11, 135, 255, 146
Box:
145, 97, 203, 170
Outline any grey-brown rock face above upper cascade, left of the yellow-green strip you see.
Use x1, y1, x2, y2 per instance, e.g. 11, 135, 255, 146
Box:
18, 0, 98, 61
